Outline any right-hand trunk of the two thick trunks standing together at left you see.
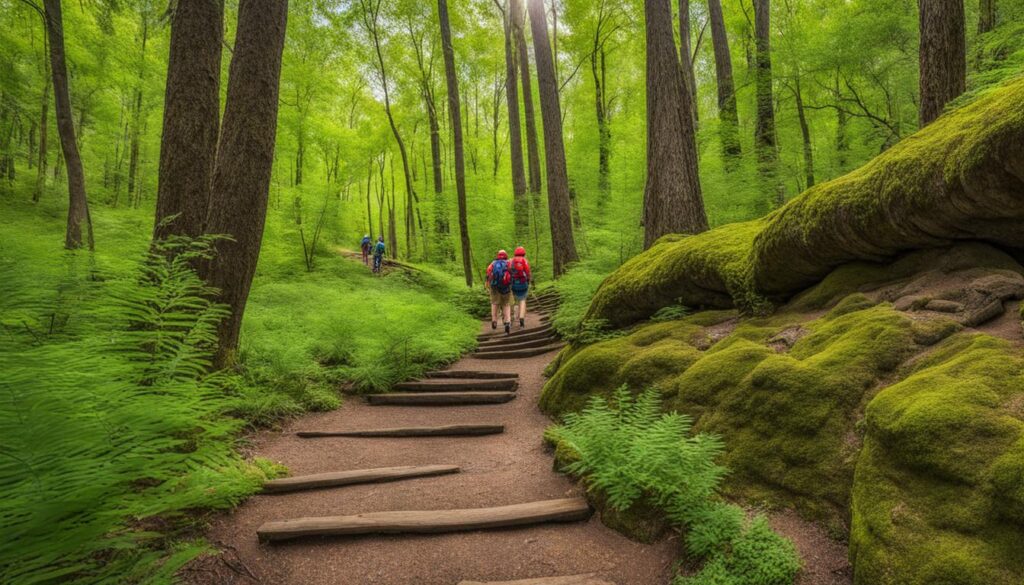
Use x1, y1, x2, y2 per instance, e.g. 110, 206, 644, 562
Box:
203, 0, 288, 366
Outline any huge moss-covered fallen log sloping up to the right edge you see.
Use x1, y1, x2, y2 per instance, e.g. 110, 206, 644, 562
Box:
587, 78, 1024, 327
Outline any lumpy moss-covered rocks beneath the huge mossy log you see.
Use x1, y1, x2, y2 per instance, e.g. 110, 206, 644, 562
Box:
541, 293, 1024, 585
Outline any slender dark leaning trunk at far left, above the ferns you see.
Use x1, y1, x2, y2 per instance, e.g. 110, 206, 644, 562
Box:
43, 0, 95, 250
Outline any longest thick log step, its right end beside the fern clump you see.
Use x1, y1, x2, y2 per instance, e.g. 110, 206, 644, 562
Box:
256, 498, 591, 542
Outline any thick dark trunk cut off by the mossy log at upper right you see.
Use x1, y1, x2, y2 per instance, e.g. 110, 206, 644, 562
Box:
918, 0, 967, 126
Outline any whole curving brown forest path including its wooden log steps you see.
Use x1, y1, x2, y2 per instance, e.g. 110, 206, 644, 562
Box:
192, 299, 678, 585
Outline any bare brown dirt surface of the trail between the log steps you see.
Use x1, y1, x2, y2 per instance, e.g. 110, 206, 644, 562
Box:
195, 316, 679, 585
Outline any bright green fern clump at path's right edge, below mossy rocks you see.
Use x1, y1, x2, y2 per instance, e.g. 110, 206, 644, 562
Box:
546, 386, 800, 585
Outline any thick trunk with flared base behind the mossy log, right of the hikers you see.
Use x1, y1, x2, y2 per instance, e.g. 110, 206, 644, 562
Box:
643, 0, 708, 248
